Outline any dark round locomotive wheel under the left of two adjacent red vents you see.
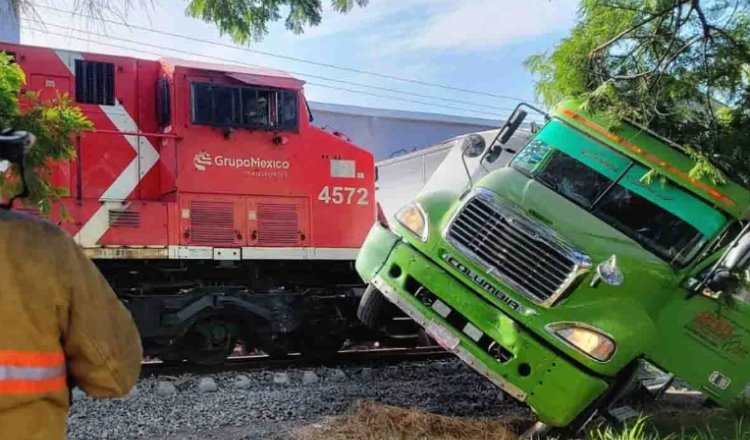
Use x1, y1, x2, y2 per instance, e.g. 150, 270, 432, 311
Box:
183, 319, 237, 366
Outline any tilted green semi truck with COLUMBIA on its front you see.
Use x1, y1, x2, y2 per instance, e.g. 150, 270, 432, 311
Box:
357, 101, 750, 429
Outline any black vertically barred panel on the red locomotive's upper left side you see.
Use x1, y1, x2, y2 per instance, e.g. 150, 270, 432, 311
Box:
76, 60, 115, 105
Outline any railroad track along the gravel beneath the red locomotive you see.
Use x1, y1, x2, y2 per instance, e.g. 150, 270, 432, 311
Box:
141, 347, 451, 377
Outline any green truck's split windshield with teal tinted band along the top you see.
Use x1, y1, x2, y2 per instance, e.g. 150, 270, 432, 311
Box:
512, 120, 726, 266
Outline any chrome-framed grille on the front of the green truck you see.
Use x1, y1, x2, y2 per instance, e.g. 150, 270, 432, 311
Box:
446, 192, 591, 304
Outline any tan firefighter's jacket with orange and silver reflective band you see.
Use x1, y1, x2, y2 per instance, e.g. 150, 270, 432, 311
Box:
0, 210, 142, 440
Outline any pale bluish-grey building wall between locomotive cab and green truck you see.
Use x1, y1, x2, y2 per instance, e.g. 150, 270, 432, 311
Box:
309, 102, 500, 161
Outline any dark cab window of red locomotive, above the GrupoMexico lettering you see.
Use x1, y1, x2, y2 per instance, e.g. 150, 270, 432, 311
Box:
191, 82, 298, 131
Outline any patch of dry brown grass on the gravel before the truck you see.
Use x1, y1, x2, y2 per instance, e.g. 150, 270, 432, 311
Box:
297, 402, 528, 440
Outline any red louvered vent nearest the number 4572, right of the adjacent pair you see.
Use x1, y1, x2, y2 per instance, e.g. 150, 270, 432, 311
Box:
258, 203, 301, 246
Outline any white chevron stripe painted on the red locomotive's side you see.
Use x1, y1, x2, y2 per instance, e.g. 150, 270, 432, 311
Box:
55, 50, 159, 247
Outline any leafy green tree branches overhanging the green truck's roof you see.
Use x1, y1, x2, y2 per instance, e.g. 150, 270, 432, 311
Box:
524, 0, 750, 186
